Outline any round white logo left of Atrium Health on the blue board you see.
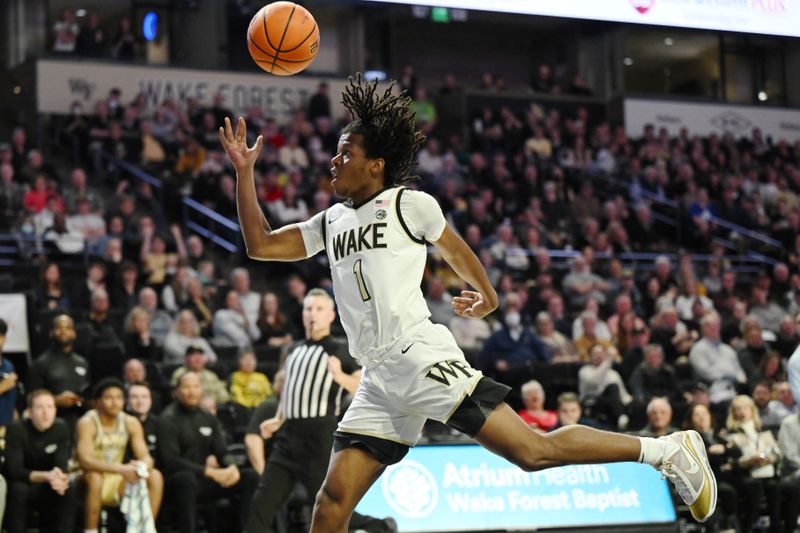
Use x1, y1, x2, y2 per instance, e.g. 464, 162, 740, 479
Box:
381, 459, 439, 518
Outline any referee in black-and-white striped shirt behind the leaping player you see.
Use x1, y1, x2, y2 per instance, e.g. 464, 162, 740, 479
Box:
247, 289, 390, 533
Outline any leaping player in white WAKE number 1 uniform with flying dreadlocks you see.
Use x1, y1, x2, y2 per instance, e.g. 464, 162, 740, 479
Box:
220, 75, 717, 533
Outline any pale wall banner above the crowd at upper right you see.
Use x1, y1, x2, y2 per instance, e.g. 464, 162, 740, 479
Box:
624, 98, 800, 143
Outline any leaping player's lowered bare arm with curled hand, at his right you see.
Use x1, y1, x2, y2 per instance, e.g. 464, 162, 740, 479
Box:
433, 224, 498, 318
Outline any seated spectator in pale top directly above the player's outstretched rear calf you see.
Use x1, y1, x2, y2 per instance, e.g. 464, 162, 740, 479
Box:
578, 344, 633, 430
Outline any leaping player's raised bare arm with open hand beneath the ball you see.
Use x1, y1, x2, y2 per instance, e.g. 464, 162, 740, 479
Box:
219, 117, 308, 261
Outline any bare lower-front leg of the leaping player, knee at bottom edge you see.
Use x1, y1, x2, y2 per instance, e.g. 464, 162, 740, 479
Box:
311, 447, 386, 533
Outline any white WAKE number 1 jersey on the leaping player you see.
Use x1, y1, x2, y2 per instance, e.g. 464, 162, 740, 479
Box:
301, 187, 446, 365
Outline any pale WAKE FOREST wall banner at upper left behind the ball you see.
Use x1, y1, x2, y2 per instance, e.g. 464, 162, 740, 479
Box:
36, 59, 345, 122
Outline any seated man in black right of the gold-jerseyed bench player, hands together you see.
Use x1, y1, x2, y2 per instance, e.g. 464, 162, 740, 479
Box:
158, 371, 257, 533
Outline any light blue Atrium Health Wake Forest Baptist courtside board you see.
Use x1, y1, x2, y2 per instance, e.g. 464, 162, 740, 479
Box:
358, 445, 675, 532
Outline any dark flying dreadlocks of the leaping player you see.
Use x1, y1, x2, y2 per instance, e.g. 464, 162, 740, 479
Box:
342, 72, 425, 187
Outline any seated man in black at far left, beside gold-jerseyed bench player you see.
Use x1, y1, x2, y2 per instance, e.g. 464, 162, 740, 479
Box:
5, 389, 77, 533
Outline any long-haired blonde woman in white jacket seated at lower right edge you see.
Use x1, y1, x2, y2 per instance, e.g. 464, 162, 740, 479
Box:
727, 395, 800, 531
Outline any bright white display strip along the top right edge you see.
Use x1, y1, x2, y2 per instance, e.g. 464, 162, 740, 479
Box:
369, 0, 800, 37
